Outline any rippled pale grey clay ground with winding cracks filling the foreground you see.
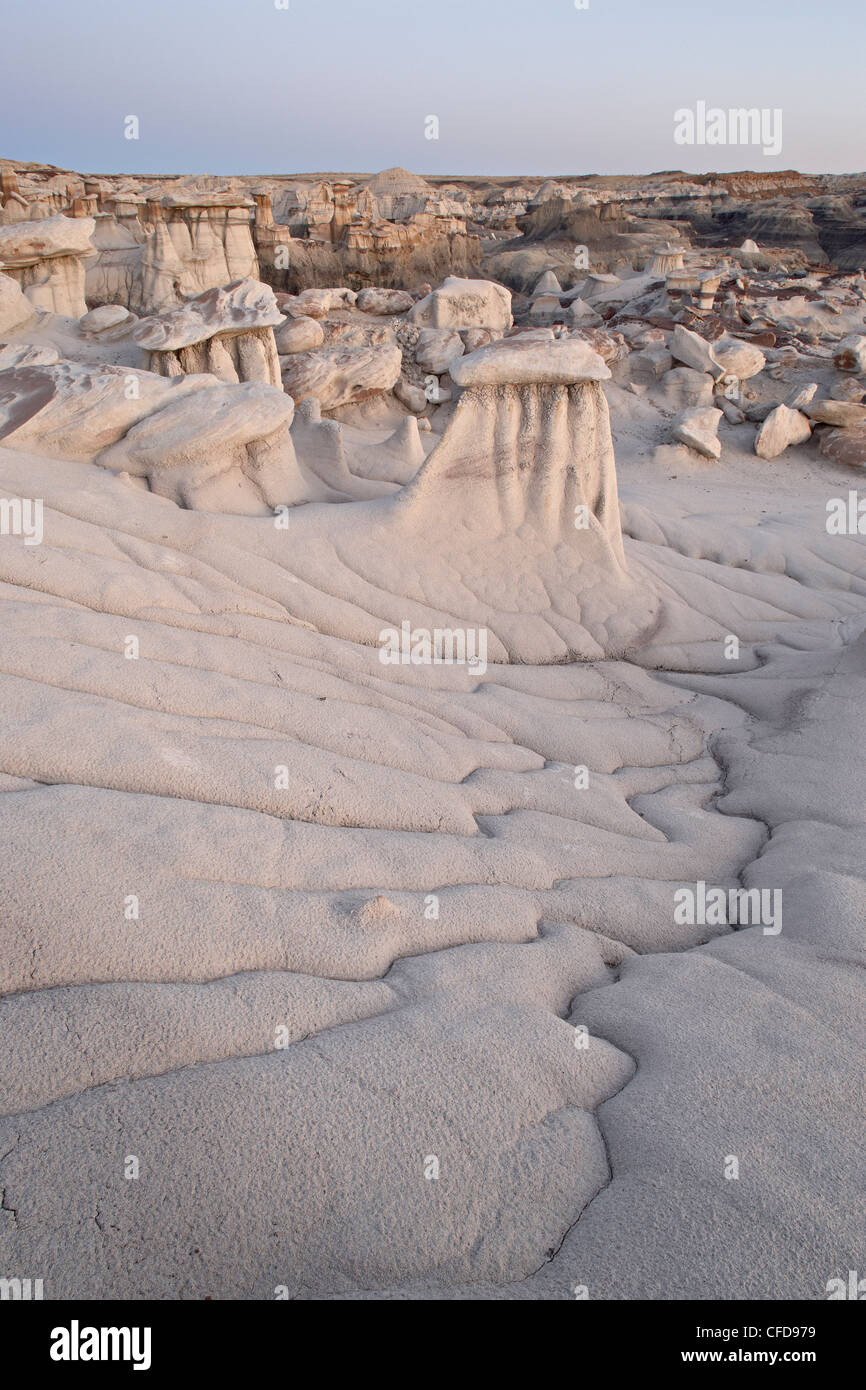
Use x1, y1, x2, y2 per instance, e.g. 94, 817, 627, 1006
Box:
0, 450, 866, 1298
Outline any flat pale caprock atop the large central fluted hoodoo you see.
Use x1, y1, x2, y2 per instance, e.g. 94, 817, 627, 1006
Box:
449, 338, 610, 386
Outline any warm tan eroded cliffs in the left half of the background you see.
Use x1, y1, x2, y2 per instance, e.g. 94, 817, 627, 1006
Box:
0, 165, 482, 314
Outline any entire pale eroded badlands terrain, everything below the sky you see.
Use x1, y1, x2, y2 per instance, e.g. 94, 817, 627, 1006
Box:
0, 161, 866, 1300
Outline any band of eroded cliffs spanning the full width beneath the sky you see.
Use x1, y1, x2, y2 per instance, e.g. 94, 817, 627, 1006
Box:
0, 161, 866, 314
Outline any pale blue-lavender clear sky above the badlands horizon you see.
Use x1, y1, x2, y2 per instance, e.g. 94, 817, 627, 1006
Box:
0, 0, 866, 174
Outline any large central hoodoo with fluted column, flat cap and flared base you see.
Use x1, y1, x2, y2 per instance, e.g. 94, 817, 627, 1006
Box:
278, 335, 657, 663
